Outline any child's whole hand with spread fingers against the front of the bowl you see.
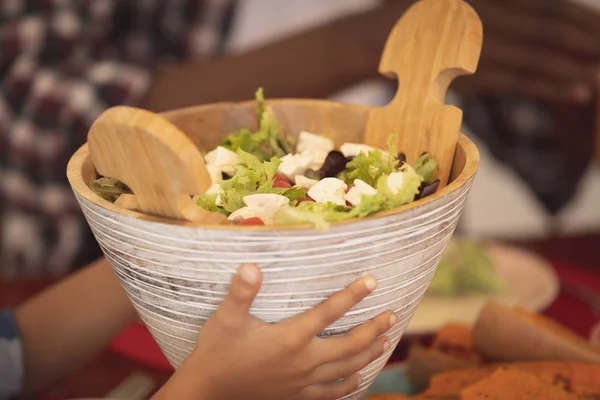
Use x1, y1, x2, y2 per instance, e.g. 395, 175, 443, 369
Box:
155, 264, 398, 400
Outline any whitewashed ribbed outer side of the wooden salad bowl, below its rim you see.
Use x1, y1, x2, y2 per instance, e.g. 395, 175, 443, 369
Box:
76, 173, 473, 399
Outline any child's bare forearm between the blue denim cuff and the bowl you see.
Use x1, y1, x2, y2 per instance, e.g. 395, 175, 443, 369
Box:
16, 258, 136, 393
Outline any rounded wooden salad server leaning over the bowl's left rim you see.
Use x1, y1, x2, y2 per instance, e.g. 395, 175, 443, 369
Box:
88, 106, 226, 223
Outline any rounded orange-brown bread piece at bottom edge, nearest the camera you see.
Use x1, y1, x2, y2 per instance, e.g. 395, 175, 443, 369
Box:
460, 368, 579, 400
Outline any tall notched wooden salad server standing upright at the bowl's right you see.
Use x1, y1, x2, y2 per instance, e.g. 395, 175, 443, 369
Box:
364, 0, 483, 187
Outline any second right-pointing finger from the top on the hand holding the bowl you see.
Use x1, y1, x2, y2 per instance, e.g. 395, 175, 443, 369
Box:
314, 312, 398, 365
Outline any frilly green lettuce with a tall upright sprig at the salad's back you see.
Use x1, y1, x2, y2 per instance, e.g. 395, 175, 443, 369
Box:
220, 88, 296, 161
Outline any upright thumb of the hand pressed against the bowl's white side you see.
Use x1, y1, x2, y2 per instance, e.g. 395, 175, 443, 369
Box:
217, 264, 262, 324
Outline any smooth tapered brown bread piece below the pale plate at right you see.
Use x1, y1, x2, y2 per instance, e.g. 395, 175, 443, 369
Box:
473, 302, 600, 362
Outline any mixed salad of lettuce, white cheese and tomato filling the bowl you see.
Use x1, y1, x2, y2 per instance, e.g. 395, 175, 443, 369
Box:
90, 89, 440, 229
